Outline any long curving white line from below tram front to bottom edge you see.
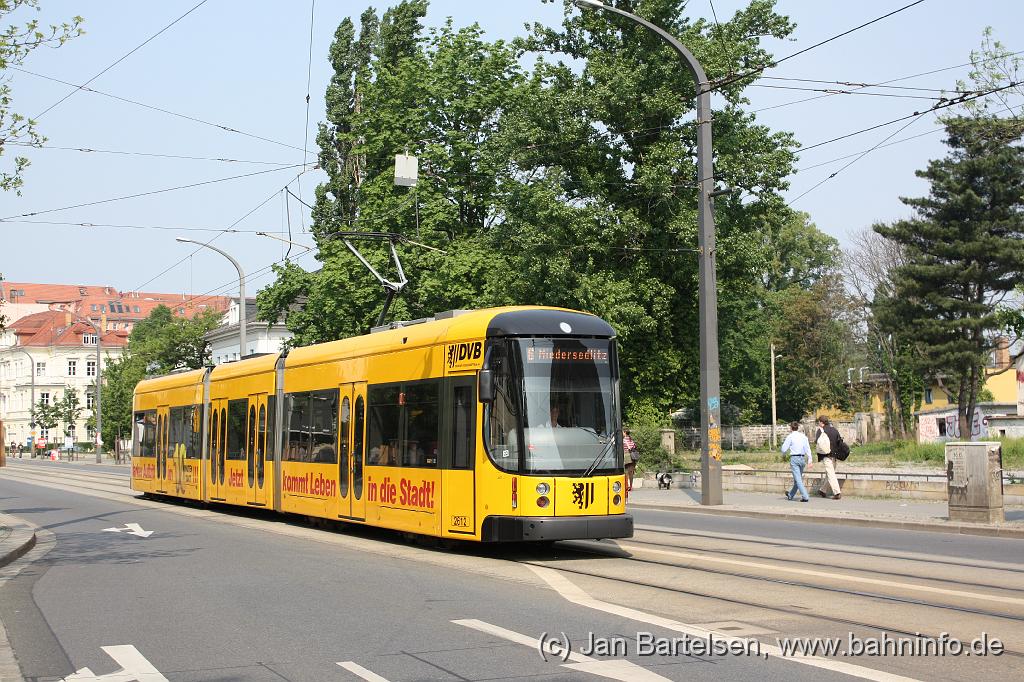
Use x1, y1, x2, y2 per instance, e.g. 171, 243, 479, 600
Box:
526, 564, 916, 682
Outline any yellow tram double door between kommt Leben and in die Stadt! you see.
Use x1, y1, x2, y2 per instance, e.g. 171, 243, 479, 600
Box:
338, 383, 367, 521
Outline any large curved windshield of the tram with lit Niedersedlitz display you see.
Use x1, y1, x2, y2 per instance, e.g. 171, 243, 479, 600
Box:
484, 339, 623, 474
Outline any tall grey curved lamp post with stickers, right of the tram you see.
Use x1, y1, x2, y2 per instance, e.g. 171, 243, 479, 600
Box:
572, 0, 722, 505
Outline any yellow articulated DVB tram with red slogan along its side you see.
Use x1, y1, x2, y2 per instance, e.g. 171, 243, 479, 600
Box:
131, 307, 633, 542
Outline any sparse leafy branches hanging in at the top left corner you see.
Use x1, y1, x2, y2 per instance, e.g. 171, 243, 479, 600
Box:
0, 0, 85, 194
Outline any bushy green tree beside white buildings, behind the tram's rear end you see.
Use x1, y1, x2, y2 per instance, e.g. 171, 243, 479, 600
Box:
101, 305, 221, 447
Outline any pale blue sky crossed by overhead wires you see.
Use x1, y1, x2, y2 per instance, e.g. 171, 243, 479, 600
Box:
0, 0, 1024, 303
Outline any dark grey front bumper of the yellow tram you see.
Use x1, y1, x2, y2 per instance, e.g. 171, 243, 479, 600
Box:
480, 514, 633, 543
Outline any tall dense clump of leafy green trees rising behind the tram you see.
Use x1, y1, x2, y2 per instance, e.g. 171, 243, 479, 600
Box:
258, 0, 813, 419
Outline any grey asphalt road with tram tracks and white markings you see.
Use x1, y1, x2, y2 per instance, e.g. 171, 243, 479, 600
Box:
0, 462, 1024, 681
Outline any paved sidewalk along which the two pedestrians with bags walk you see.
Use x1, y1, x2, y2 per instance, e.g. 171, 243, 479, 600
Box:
628, 481, 1024, 540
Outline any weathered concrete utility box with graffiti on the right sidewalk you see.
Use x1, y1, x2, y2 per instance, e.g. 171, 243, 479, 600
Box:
946, 441, 1006, 523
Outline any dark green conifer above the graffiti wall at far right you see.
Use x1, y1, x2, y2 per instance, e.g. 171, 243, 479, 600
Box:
874, 117, 1024, 433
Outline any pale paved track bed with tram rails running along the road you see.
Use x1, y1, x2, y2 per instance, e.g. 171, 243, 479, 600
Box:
2, 462, 1024, 679
